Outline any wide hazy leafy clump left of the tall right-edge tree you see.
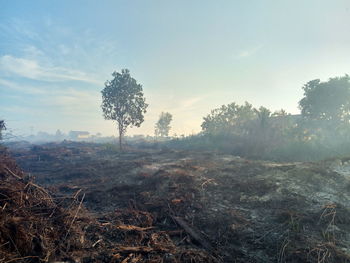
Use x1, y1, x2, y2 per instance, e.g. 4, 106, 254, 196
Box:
202, 102, 295, 157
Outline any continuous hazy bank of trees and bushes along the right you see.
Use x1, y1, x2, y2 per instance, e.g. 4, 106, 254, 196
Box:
167, 75, 350, 160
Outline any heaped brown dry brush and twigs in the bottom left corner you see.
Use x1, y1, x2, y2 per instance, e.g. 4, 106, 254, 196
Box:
0, 154, 87, 262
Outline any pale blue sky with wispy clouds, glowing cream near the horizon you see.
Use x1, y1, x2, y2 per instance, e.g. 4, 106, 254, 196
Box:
0, 0, 350, 136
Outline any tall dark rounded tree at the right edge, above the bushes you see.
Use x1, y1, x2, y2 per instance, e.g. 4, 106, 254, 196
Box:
299, 75, 350, 149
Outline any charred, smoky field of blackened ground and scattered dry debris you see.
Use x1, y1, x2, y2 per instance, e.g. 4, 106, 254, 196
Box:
0, 142, 350, 263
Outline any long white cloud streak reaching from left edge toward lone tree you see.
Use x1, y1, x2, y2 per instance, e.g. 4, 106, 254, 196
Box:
0, 55, 103, 85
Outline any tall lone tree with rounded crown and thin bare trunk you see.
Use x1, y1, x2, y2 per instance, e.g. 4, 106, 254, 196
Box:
101, 69, 148, 150
